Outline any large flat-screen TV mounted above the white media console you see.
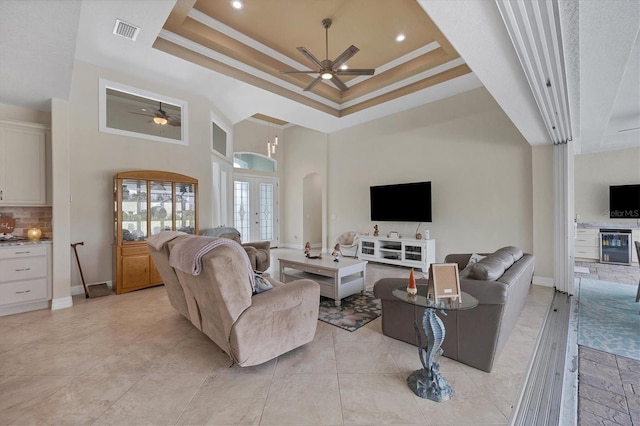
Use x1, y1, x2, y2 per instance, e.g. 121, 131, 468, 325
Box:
369, 182, 431, 222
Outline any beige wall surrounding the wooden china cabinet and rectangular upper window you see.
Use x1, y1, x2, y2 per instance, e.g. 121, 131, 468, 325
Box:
65, 61, 232, 285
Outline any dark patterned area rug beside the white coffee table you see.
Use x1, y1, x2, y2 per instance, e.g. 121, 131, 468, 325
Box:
318, 291, 382, 331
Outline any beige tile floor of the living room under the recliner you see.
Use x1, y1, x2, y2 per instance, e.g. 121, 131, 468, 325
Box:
0, 249, 553, 425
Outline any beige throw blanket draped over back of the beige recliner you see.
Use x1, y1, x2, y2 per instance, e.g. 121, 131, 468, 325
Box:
169, 237, 255, 288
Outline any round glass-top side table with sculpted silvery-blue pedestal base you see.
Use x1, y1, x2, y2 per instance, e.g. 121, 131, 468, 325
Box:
393, 285, 478, 402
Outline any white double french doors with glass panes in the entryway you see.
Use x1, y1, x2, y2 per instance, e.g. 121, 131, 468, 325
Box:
233, 174, 279, 247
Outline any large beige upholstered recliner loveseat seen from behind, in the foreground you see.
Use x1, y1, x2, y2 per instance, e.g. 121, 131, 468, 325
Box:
147, 235, 320, 366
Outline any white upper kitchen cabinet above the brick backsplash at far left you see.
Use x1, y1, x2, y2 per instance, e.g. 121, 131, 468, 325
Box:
0, 121, 49, 206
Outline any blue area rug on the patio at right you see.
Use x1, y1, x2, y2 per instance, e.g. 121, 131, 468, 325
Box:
578, 278, 640, 360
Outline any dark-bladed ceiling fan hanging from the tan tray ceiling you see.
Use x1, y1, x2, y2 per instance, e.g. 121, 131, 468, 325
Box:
282, 18, 375, 91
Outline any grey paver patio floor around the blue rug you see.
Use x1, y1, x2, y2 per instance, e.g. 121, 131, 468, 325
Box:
576, 262, 640, 426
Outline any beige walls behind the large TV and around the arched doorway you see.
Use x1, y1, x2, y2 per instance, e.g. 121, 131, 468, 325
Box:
284, 89, 533, 261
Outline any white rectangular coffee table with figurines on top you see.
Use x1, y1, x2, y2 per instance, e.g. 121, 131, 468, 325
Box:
279, 254, 368, 306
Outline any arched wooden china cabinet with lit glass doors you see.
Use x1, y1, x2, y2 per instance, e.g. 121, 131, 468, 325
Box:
113, 170, 198, 294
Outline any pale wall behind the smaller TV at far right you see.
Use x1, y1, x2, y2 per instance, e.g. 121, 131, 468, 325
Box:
574, 147, 640, 224
